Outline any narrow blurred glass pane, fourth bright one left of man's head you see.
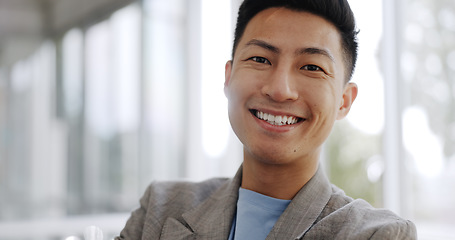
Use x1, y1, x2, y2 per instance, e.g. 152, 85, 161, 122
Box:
84, 18, 116, 213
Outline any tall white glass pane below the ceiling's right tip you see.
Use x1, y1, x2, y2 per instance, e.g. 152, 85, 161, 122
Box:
109, 4, 142, 210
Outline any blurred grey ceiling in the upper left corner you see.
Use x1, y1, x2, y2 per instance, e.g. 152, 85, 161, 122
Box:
0, 0, 137, 67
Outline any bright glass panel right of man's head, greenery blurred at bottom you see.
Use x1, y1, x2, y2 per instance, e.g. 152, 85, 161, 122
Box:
324, 0, 385, 207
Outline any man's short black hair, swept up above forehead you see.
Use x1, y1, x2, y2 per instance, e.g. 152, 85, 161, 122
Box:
232, 0, 358, 81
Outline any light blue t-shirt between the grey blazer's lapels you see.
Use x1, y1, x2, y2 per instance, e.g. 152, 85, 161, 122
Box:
229, 188, 291, 240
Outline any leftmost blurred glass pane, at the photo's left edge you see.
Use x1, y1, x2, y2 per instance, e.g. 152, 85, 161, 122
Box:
0, 60, 31, 220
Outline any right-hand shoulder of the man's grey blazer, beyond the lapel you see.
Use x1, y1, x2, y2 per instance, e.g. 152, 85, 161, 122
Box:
308, 186, 417, 239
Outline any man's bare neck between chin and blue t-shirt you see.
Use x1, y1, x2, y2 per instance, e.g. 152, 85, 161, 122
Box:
242, 155, 318, 200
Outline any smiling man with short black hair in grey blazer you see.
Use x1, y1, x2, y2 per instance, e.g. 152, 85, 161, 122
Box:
119, 0, 416, 240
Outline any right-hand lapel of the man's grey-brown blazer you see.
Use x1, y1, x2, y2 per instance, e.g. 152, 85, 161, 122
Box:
266, 167, 332, 240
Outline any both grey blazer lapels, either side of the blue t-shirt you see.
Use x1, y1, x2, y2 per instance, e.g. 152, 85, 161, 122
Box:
161, 166, 332, 240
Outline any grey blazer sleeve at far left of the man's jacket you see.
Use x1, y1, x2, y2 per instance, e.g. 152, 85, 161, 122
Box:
115, 187, 151, 240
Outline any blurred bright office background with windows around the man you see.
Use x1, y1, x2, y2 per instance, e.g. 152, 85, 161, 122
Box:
0, 0, 455, 240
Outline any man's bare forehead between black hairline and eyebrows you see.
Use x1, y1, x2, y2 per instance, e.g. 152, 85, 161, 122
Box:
238, 8, 342, 60
